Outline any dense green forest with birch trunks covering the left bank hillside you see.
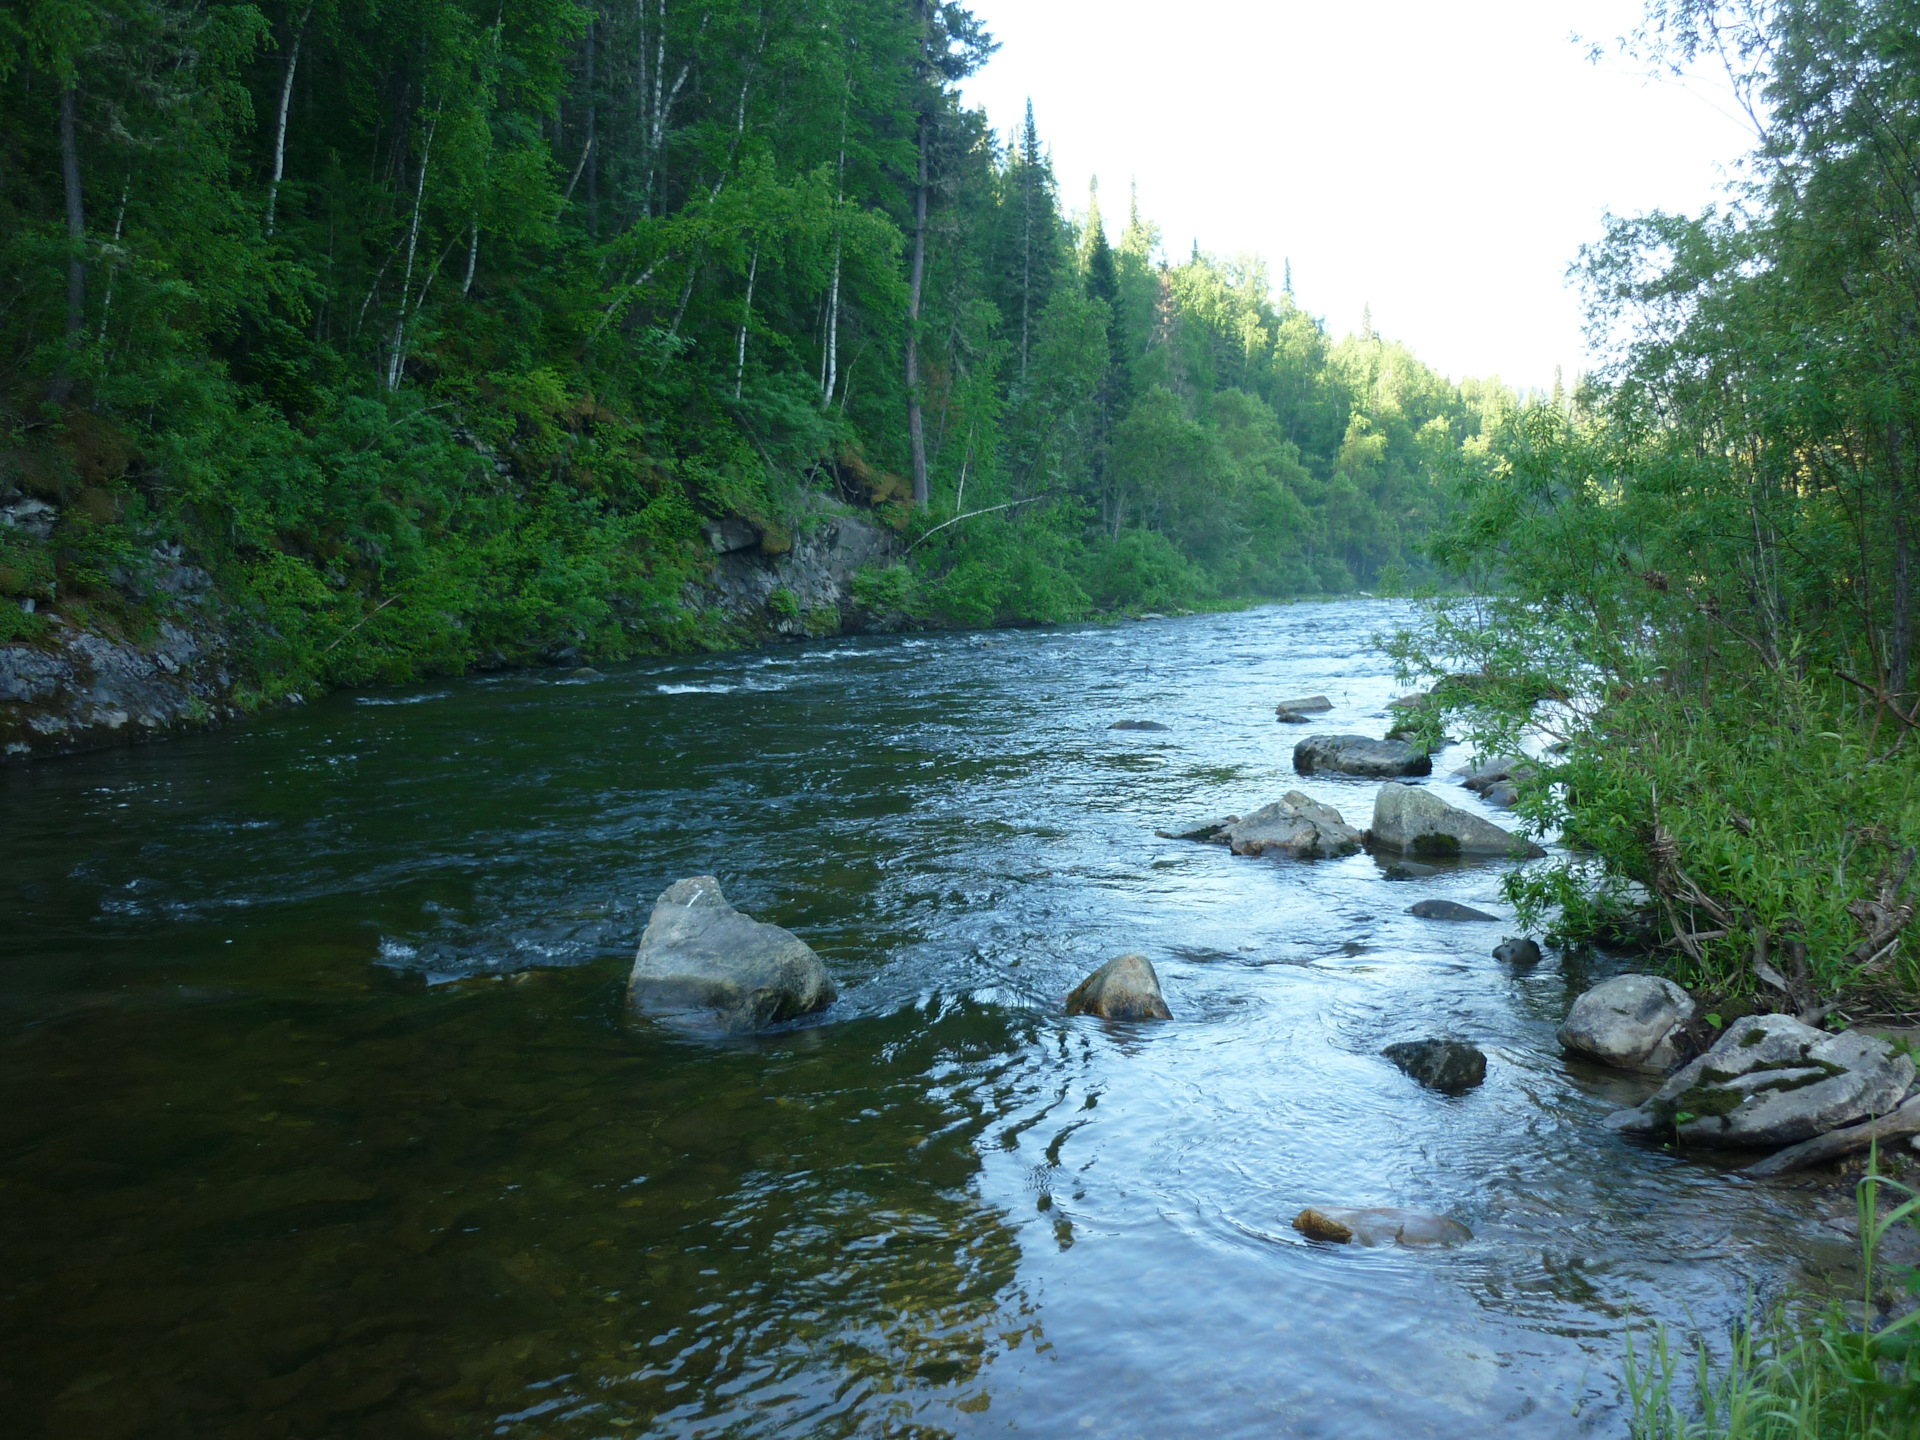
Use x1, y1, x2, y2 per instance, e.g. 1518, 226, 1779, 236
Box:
0, 0, 1507, 689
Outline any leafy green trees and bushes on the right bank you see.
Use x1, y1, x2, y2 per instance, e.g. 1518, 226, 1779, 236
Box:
1400, 0, 1920, 1014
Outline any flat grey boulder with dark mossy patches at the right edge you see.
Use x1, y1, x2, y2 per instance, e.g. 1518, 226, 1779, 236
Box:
1607, 1016, 1914, 1148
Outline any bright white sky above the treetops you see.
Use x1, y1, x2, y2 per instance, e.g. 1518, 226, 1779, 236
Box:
966, 0, 1751, 388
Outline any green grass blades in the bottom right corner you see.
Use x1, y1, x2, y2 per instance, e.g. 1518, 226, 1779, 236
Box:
1626, 1154, 1920, 1440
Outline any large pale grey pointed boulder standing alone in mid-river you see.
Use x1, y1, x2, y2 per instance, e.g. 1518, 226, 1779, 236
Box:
626, 876, 833, 1033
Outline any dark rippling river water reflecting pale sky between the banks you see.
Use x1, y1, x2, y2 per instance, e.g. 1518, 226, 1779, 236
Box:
0, 603, 1836, 1440
